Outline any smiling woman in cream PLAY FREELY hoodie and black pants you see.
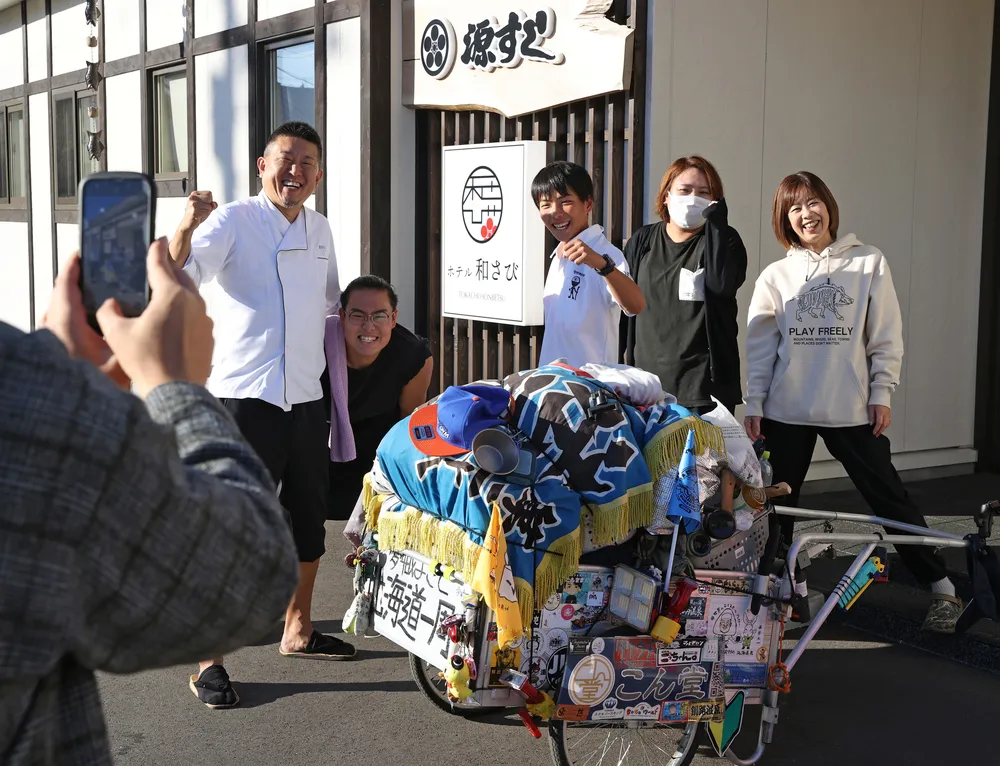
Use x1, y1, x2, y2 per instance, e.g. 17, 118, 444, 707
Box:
745, 172, 962, 633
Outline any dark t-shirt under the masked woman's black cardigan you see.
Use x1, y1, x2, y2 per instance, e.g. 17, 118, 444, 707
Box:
635, 225, 712, 407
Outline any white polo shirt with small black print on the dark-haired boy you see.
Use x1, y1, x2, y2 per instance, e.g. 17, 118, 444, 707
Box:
538, 225, 629, 367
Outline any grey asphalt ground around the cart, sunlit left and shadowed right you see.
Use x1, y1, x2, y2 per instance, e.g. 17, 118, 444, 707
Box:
100, 510, 1000, 766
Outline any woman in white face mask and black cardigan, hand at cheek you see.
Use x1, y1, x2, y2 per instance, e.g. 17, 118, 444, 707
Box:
625, 156, 747, 413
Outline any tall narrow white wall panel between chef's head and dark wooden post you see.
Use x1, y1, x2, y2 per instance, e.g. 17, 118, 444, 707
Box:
325, 19, 362, 286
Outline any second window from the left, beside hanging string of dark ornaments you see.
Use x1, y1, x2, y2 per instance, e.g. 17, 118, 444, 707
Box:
52, 91, 98, 204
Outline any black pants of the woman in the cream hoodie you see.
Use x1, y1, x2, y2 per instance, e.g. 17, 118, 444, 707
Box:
760, 418, 947, 584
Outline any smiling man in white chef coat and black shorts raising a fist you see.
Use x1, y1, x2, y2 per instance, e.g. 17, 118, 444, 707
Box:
170, 122, 355, 708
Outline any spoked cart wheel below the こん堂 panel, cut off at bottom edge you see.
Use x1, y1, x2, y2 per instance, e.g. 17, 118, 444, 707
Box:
549, 721, 701, 766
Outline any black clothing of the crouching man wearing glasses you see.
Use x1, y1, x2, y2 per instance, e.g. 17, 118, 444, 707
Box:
324, 325, 431, 519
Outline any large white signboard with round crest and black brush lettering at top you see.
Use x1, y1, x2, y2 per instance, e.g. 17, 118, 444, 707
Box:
403, 0, 632, 117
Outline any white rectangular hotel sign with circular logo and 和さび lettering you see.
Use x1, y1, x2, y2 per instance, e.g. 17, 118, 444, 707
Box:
441, 141, 549, 326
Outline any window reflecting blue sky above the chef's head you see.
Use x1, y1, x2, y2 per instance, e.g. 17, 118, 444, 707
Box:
264, 39, 316, 138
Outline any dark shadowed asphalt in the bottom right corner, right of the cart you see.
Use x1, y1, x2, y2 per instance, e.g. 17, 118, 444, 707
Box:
716, 631, 1000, 766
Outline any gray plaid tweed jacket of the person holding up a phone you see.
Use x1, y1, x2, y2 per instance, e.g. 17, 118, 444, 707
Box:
0, 323, 298, 766
